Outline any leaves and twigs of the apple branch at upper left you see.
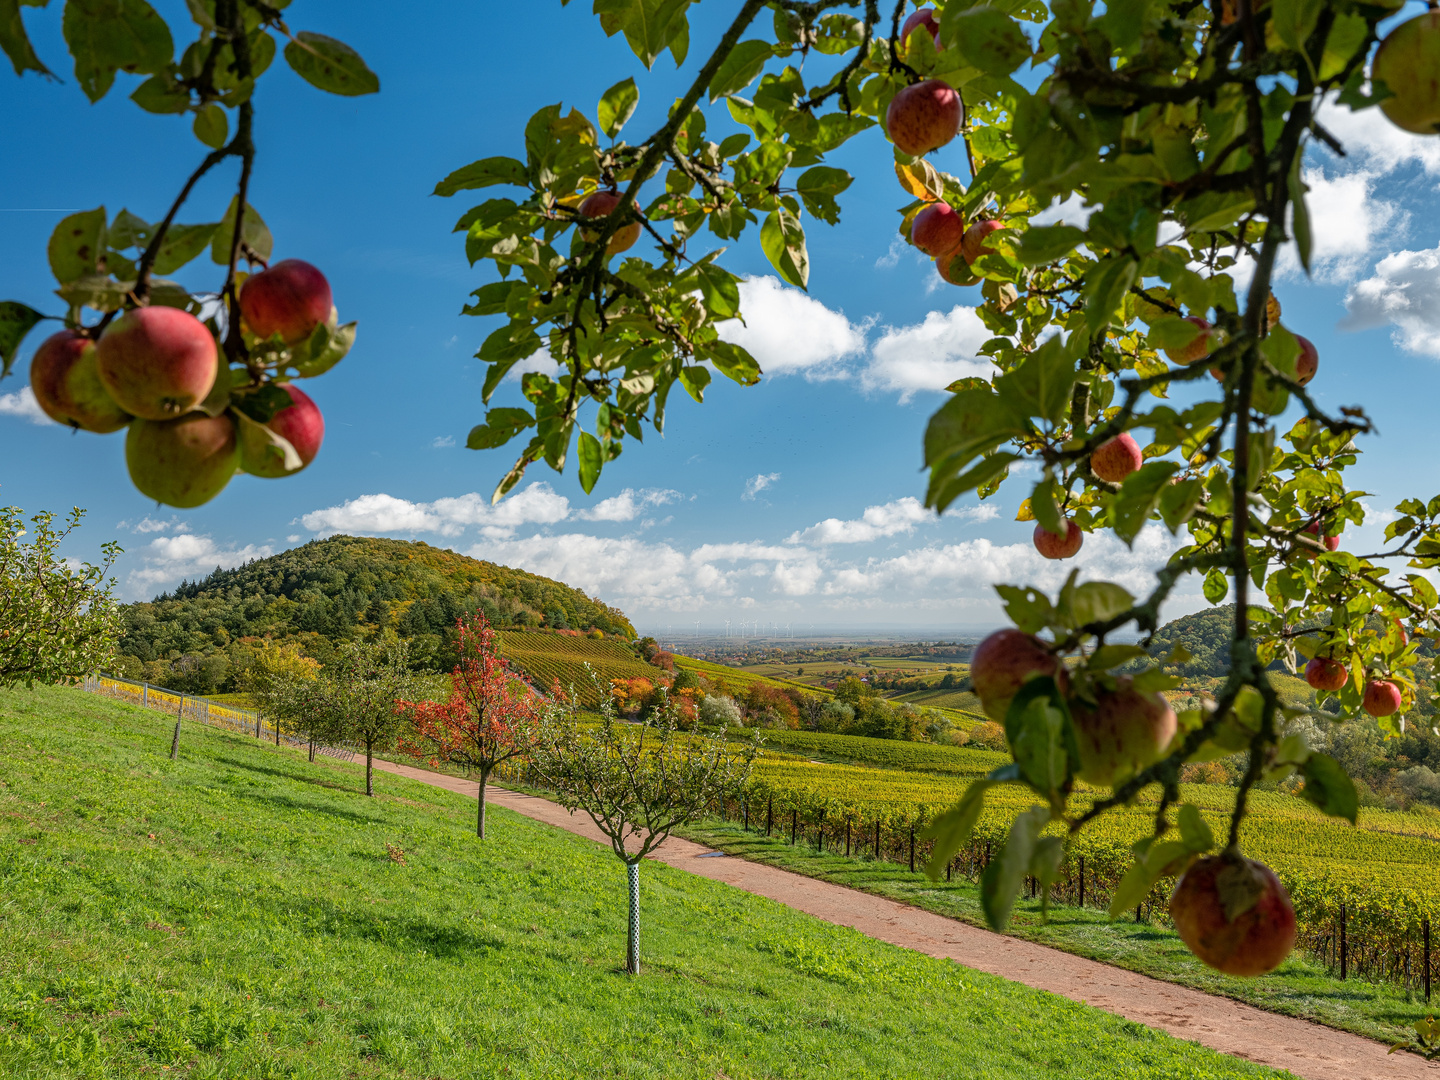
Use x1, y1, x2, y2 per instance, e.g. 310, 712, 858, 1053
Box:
0, 0, 380, 489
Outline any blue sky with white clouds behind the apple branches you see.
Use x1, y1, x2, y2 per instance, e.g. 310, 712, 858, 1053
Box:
0, 0, 1440, 632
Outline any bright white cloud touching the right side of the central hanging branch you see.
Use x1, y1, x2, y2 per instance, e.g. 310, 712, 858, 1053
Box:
716, 276, 867, 379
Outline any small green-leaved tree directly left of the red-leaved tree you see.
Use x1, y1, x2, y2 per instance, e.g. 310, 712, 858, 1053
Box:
324, 641, 419, 795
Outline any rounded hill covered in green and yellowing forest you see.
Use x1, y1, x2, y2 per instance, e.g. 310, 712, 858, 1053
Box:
117, 536, 635, 693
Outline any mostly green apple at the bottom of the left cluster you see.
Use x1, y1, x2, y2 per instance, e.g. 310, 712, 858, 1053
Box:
125, 412, 240, 510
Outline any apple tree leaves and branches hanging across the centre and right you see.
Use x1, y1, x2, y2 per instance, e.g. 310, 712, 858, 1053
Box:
446, 0, 1440, 944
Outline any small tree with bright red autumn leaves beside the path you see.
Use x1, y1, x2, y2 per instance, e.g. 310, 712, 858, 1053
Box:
400, 612, 540, 840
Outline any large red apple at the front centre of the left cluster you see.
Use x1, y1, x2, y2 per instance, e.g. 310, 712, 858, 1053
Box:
95, 307, 219, 420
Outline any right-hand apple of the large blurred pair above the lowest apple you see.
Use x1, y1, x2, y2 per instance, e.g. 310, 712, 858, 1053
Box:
1070, 675, 1178, 788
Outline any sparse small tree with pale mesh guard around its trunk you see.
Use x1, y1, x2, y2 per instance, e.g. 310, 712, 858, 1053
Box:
534, 694, 759, 975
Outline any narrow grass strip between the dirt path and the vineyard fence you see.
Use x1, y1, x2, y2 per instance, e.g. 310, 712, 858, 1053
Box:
681, 821, 1436, 1059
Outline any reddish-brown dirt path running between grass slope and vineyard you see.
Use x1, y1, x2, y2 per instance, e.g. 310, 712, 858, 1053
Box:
362, 760, 1440, 1080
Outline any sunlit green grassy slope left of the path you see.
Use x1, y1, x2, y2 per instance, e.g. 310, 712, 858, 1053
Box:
0, 688, 1276, 1080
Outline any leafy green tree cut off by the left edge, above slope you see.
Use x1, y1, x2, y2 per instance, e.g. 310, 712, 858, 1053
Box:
0, 507, 121, 687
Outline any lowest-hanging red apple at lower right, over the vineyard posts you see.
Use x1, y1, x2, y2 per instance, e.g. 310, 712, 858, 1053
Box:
1171, 855, 1295, 975
